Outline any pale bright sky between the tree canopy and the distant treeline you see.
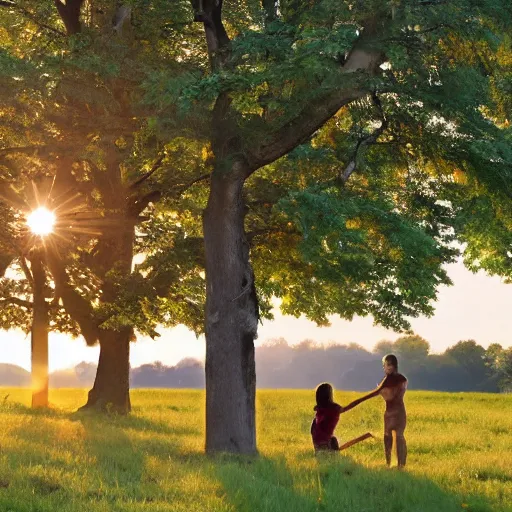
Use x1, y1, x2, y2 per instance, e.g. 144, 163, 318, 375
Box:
0, 262, 512, 371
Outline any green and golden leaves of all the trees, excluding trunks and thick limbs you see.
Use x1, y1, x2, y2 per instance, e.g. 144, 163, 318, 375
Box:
1, 0, 512, 344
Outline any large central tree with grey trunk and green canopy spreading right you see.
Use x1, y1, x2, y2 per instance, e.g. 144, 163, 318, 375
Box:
176, 0, 512, 453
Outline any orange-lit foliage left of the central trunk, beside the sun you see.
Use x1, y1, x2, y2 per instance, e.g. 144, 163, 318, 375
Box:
0, 1, 211, 343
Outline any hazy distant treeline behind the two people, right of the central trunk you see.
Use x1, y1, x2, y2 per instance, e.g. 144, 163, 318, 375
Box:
256, 336, 512, 393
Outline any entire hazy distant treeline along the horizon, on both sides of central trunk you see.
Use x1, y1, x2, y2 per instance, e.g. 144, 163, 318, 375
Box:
0, 336, 512, 393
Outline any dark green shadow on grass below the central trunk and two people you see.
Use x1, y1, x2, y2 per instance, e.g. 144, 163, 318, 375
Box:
214, 454, 500, 512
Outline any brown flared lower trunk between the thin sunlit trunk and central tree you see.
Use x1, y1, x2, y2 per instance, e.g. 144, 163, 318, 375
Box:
82, 329, 132, 414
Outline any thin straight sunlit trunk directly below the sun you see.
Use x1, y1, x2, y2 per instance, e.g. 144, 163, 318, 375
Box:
30, 251, 49, 407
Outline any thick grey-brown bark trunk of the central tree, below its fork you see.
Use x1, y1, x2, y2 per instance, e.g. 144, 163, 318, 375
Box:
203, 162, 258, 454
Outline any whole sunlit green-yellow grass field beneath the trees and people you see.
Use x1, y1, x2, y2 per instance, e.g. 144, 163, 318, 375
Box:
0, 389, 512, 512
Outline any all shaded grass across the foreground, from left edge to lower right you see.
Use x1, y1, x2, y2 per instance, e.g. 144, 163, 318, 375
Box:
0, 404, 504, 512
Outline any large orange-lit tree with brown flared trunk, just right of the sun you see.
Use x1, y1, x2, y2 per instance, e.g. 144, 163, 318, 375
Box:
0, 0, 207, 412
